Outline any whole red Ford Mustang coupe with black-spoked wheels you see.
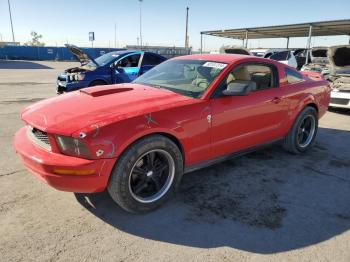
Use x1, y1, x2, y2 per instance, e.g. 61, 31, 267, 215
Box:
14, 54, 330, 212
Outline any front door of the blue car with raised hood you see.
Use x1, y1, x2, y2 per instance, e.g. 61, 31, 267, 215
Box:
114, 52, 143, 83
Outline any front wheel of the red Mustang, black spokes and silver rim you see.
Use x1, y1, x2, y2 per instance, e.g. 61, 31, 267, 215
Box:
107, 135, 183, 213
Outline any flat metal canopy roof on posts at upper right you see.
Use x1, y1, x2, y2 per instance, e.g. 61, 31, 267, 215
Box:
201, 19, 350, 40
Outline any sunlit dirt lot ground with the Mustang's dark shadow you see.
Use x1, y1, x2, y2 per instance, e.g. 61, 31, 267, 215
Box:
0, 61, 350, 261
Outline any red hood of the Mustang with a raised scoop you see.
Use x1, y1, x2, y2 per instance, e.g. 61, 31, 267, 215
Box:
21, 83, 193, 136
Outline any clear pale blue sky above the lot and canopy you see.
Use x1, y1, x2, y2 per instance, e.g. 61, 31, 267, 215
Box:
0, 0, 350, 50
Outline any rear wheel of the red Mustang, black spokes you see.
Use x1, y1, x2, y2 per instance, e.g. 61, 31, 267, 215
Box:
283, 106, 318, 154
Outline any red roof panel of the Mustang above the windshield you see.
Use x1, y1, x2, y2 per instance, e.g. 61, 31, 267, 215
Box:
173, 54, 255, 64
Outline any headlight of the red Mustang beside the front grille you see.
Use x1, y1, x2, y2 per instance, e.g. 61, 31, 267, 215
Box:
56, 135, 91, 159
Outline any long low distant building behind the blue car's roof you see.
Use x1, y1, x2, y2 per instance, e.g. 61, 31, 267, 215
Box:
126, 45, 192, 58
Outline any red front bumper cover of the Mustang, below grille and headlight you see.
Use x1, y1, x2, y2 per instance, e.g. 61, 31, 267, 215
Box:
13, 127, 116, 193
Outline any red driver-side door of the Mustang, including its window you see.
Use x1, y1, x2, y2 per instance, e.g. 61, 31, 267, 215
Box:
210, 62, 287, 156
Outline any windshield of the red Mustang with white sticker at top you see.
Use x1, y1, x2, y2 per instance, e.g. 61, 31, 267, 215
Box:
134, 59, 227, 98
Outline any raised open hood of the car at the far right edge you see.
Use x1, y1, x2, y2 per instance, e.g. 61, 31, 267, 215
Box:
328, 45, 350, 75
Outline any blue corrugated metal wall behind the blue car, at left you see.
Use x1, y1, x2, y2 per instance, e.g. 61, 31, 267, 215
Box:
0, 46, 124, 61
